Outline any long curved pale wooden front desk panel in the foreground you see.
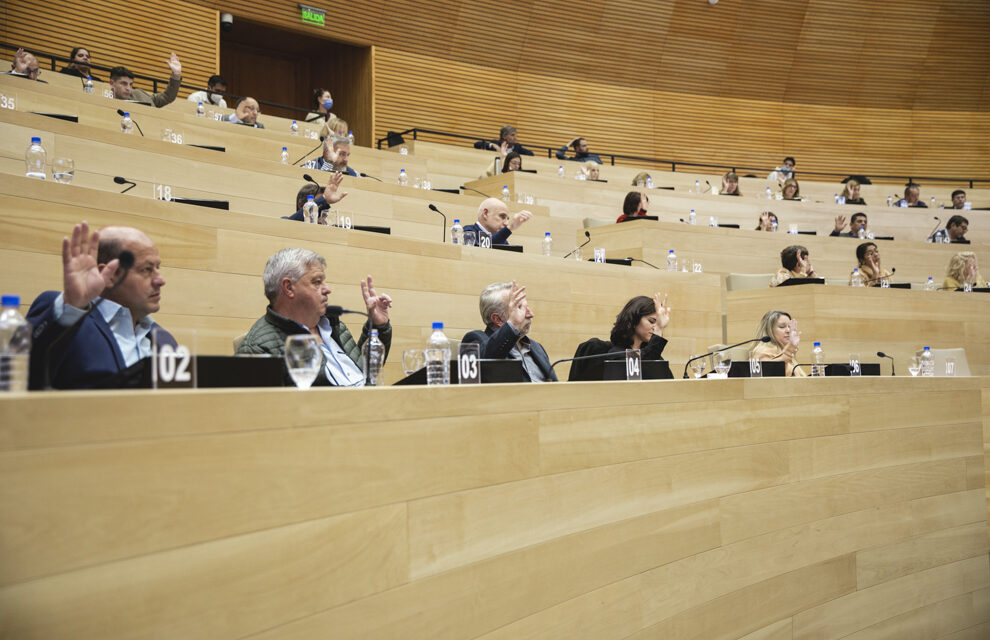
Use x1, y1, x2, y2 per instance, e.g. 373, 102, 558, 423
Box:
0, 378, 990, 640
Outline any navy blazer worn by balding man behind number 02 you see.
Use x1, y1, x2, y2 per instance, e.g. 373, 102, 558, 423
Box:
27, 291, 178, 389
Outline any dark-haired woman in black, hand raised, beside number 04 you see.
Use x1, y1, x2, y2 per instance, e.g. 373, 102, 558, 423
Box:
567, 293, 670, 380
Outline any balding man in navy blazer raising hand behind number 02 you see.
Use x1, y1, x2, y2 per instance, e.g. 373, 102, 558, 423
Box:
27, 221, 176, 389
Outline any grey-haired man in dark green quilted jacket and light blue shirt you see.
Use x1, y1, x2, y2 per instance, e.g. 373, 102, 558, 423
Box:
237, 249, 392, 387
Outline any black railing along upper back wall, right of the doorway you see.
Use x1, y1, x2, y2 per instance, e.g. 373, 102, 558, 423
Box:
377, 127, 990, 189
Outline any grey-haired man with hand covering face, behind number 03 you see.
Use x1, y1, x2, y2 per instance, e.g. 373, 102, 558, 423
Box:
461, 282, 557, 382
